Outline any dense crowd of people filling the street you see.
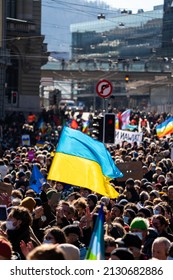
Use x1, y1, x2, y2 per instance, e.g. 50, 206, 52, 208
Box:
0, 107, 173, 260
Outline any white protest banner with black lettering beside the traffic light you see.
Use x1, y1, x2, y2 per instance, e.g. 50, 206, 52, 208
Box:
115, 129, 142, 145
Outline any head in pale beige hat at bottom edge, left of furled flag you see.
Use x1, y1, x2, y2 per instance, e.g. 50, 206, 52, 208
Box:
58, 243, 80, 260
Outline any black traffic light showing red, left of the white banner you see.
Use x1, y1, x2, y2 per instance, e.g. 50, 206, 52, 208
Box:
103, 113, 115, 144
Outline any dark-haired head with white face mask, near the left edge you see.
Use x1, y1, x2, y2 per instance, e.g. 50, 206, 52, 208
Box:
6, 206, 33, 230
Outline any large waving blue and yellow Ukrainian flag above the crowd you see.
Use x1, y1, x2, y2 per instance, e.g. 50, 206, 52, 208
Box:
47, 126, 123, 198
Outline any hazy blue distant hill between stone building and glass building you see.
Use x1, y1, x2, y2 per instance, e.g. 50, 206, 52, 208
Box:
41, 0, 118, 52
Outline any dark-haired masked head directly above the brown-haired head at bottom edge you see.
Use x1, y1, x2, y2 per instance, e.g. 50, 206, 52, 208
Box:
43, 226, 66, 244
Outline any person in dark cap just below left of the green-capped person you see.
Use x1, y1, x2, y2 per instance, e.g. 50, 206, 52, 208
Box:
117, 232, 148, 260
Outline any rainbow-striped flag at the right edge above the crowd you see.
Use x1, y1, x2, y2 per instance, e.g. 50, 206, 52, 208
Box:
156, 117, 173, 138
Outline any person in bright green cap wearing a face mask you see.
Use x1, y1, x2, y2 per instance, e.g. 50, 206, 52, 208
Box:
130, 217, 158, 258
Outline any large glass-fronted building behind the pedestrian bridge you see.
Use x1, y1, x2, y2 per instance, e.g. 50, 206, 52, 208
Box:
70, 5, 163, 60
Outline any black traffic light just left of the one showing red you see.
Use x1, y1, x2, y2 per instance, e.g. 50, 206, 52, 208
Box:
91, 116, 103, 142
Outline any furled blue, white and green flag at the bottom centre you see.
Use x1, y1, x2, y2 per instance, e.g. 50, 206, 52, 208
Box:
85, 205, 105, 260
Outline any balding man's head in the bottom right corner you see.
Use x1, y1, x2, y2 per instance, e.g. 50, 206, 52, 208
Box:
151, 237, 171, 260
